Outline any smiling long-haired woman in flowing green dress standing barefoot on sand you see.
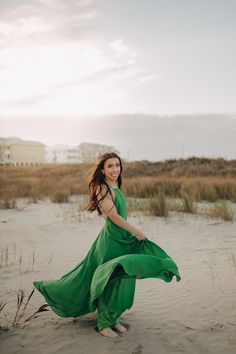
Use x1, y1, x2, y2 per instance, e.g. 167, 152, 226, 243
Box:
34, 152, 180, 337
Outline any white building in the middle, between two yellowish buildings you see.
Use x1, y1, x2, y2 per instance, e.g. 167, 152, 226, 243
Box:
46, 145, 82, 163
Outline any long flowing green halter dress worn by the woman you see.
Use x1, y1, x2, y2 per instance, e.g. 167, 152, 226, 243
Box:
33, 187, 181, 330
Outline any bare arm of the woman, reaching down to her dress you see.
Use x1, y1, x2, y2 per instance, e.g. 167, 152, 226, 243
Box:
97, 186, 146, 240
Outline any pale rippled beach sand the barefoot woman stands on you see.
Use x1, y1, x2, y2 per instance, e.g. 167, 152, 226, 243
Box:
0, 198, 236, 354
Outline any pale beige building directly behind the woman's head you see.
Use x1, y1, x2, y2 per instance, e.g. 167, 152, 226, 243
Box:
79, 143, 119, 163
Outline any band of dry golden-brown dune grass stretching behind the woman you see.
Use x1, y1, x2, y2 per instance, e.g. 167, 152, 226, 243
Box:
0, 158, 236, 208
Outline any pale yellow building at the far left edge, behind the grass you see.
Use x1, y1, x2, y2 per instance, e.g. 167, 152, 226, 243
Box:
0, 137, 45, 166
